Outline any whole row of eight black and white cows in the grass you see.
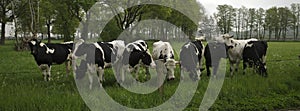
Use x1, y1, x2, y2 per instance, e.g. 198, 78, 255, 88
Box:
28, 34, 268, 88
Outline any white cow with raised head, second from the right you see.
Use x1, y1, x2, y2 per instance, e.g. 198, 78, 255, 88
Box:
222, 34, 258, 76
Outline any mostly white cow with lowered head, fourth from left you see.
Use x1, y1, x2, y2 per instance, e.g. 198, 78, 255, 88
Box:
152, 41, 176, 80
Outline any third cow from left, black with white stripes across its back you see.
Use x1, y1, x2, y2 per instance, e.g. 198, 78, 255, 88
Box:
121, 40, 156, 82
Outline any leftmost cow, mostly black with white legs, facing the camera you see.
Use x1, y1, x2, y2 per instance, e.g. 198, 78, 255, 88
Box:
28, 39, 73, 81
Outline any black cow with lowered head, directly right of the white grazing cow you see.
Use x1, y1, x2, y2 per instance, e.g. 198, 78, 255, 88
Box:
180, 40, 204, 80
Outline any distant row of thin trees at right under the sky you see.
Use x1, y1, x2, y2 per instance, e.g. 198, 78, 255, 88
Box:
200, 3, 300, 41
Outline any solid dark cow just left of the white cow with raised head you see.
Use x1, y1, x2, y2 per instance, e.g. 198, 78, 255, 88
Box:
204, 41, 227, 76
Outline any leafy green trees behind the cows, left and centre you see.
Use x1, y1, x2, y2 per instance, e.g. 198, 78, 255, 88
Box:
0, 0, 204, 50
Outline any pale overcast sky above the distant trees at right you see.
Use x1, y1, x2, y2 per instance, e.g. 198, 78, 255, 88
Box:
197, 0, 300, 15
